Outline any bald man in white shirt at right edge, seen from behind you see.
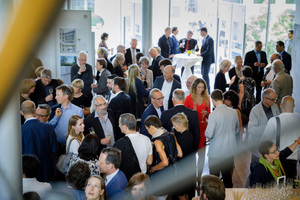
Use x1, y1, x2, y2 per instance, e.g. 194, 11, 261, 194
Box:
262, 96, 300, 178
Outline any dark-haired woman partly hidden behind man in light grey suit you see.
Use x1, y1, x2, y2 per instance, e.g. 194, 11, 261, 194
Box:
224, 90, 243, 141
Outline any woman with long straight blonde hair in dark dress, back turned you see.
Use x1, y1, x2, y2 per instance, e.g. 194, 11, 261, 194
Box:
126, 64, 149, 118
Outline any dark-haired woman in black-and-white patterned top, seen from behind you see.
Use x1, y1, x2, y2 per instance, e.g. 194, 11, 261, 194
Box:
69, 134, 100, 176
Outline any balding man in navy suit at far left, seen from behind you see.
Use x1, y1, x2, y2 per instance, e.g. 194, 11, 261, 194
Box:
21, 100, 57, 182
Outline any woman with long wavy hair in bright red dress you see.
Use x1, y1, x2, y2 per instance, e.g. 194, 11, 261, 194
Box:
184, 78, 210, 148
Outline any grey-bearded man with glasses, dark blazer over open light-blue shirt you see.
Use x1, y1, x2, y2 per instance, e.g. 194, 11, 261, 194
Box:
84, 95, 116, 149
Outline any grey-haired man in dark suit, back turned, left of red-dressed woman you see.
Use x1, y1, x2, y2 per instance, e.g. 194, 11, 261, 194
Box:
160, 89, 200, 151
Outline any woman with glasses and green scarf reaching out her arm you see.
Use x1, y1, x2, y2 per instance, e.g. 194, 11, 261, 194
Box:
250, 137, 300, 186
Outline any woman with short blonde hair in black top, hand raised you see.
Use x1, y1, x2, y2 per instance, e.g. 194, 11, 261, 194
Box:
214, 59, 236, 92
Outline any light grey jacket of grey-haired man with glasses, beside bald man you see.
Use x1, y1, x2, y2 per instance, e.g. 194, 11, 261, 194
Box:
248, 102, 280, 157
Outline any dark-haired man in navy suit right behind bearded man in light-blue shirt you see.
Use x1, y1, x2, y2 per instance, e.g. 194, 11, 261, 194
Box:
108, 77, 131, 141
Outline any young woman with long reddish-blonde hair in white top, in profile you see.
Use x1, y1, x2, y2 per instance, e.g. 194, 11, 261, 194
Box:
66, 115, 84, 154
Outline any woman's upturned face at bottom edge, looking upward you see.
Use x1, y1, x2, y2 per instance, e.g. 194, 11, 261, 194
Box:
85, 176, 108, 200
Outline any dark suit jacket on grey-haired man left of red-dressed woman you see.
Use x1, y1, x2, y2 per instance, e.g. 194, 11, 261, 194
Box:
160, 105, 200, 151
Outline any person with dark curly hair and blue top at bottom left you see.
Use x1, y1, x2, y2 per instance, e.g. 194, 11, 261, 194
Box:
66, 162, 91, 200
